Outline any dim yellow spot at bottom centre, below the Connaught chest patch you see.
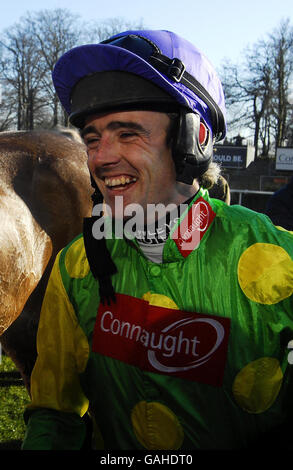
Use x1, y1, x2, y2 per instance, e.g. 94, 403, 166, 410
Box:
131, 401, 184, 450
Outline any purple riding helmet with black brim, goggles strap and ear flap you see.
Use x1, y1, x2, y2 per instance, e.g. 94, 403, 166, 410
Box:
53, 30, 226, 184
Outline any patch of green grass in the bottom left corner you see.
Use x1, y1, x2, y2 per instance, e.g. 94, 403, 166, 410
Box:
0, 355, 29, 450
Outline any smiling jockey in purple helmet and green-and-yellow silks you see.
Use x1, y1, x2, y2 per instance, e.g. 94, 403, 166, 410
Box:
23, 31, 293, 452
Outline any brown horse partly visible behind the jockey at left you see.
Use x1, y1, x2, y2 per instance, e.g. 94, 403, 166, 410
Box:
0, 131, 92, 389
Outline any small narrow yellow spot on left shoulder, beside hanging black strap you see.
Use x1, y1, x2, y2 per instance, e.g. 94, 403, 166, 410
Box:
65, 238, 90, 279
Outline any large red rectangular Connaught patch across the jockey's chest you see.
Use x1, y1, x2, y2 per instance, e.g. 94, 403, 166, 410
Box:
93, 294, 230, 386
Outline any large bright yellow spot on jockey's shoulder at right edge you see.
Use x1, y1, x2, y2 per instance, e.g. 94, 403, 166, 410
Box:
238, 243, 293, 304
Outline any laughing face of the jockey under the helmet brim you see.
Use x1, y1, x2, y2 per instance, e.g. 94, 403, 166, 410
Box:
82, 111, 184, 218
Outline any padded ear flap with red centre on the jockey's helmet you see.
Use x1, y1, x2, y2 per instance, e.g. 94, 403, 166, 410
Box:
172, 109, 213, 184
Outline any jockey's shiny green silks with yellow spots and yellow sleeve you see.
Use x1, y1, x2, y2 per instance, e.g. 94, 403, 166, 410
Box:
24, 190, 293, 450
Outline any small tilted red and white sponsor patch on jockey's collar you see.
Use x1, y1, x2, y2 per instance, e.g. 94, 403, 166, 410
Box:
172, 197, 216, 258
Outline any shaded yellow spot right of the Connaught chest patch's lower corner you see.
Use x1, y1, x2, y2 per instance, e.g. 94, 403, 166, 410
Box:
232, 357, 283, 413
